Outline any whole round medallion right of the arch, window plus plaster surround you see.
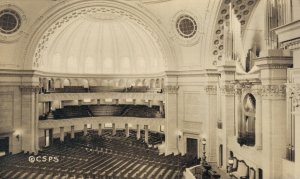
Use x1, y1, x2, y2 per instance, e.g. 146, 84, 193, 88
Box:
171, 11, 201, 46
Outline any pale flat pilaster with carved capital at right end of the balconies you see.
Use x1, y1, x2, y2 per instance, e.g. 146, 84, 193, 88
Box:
164, 84, 179, 155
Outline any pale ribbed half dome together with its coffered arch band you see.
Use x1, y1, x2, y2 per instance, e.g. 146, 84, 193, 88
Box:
27, 1, 173, 74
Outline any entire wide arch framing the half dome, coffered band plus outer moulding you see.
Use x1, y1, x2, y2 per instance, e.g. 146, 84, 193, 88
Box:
23, 0, 177, 73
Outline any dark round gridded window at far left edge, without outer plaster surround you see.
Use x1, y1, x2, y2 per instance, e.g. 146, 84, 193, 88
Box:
0, 9, 21, 34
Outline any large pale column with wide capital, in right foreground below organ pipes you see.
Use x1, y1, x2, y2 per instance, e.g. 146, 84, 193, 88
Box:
255, 55, 292, 178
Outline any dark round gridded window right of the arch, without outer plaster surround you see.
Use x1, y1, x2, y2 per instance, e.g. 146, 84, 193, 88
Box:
176, 15, 197, 38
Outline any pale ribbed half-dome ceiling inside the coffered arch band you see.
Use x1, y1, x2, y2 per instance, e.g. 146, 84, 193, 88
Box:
40, 13, 165, 74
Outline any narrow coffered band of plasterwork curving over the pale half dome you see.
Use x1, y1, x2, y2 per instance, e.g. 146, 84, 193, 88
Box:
33, 7, 166, 68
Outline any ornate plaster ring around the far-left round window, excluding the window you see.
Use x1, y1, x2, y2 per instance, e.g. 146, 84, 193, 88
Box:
0, 3, 28, 43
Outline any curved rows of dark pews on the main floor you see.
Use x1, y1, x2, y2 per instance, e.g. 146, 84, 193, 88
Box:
0, 130, 199, 179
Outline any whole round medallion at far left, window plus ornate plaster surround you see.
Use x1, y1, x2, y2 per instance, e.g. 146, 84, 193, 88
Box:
0, 4, 26, 43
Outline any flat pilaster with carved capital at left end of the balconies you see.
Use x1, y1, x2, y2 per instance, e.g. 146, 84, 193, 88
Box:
20, 85, 39, 153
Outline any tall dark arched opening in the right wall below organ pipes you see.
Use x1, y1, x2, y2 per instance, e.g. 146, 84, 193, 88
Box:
238, 93, 256, 146
